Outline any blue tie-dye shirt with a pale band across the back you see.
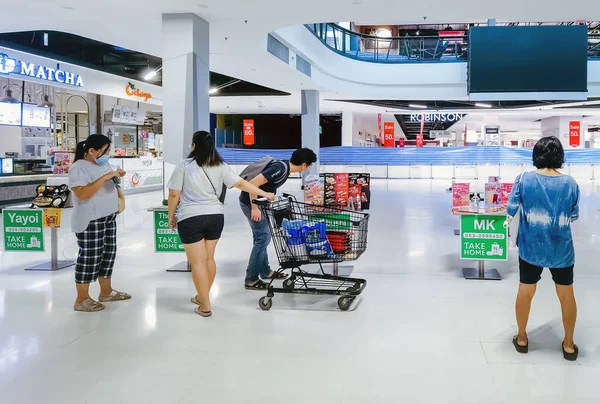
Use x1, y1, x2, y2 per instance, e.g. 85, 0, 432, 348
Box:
506, 172, 579, 268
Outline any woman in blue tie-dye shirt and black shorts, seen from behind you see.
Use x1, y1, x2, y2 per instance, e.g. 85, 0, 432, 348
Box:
507, 137, 579, 360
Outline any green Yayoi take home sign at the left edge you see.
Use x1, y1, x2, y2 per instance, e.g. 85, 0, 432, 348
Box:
3, 209, 44, 251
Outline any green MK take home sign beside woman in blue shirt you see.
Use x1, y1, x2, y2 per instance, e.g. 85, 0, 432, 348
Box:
460, 215, 508, 261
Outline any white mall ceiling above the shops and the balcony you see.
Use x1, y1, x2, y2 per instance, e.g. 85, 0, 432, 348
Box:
0, 0, 600, 129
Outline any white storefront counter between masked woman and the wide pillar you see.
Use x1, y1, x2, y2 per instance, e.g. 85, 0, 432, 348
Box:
110, 157, 163, 195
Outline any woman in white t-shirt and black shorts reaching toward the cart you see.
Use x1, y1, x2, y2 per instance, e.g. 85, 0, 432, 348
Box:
168, 131, 275, 317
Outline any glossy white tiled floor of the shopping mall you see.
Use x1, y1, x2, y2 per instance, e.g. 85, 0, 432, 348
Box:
0, 180, 600, 404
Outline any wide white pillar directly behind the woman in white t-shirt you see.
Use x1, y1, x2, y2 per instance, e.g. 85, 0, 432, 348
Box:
162, 14, 210, 164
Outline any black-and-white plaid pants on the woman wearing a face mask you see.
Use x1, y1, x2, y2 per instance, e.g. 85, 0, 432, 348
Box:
75, 214, 117, 283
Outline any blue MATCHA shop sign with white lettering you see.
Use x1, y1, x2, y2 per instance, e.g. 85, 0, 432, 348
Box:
0, 53, 84, 87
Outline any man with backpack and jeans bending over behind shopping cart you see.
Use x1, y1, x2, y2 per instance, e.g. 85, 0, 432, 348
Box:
240, 148, 317, 290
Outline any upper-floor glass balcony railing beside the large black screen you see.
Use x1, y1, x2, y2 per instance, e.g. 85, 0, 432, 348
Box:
306, 23, 600, 63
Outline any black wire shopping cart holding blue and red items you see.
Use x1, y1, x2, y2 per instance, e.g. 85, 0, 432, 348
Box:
254, 194, 369, 311
